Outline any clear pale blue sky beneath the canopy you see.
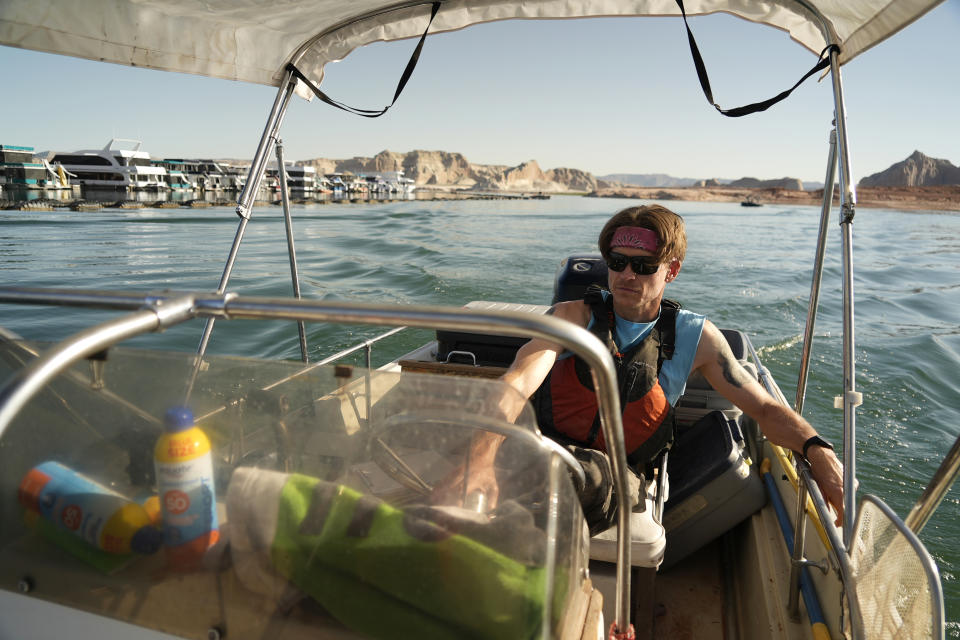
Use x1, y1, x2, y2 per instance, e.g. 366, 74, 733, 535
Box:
0, 0, 960, 181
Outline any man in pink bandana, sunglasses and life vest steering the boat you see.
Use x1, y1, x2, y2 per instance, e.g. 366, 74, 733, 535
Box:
438, 205, 843, 530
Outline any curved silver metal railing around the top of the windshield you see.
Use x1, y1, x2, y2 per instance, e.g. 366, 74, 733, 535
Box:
0, 288, 631, 631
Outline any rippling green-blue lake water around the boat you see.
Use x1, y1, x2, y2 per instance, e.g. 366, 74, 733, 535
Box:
0, 197, 960, 638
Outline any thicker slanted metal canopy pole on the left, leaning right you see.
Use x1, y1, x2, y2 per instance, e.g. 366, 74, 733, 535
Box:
185, 70, 297, 400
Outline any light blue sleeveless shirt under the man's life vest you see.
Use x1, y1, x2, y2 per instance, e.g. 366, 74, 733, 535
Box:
587, 291, 705, 406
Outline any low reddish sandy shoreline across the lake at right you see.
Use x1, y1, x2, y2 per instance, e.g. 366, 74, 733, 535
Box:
587, 185, 960, 212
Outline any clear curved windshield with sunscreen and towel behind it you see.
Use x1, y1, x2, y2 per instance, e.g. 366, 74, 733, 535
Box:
0, 343, 586, 638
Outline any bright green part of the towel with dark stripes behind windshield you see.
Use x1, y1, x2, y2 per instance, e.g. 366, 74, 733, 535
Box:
271, 474, 548, 640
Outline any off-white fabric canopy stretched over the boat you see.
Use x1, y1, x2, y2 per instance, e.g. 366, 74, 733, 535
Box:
0, 0, 941, 92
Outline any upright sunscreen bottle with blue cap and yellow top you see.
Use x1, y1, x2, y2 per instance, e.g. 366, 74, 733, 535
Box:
154, 407, 220, 569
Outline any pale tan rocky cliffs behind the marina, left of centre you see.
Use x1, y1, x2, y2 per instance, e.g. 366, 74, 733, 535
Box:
302, 151, 597, 193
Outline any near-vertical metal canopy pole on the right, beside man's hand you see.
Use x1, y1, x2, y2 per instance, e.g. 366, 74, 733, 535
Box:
830, 49, 862, 549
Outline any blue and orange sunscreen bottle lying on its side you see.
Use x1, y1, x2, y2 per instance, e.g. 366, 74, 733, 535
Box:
17, 460, 162, 554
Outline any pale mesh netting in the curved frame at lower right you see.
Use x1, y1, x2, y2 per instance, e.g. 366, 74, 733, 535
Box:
850, 500, 941, 640
